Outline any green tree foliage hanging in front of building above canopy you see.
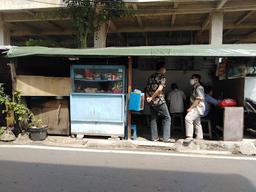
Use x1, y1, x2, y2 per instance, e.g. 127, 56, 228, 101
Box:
64, 0, 131, 48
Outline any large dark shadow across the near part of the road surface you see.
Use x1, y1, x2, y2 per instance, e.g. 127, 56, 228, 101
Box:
0, 161, 256, 192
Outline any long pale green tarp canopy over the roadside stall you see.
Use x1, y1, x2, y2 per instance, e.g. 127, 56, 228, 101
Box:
7, 44, 256, 58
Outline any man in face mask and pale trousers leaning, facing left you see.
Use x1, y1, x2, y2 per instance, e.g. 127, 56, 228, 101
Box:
184, 74, 205, 145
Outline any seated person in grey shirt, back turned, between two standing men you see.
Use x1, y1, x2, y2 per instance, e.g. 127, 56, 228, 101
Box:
167, 83, 186, 114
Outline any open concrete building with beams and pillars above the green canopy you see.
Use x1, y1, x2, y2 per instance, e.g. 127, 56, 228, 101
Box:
0, 0, 256, 47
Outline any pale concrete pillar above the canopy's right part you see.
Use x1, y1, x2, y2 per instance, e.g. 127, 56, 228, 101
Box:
209, 13, 223, 45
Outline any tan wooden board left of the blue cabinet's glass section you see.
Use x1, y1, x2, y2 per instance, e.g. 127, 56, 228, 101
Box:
16, 75, 71, 96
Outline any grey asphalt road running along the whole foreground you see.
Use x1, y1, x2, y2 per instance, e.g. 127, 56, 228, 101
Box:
0, 146, 256, 192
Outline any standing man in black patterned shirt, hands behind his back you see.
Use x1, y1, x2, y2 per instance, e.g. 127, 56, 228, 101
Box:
145, 63, 175, 142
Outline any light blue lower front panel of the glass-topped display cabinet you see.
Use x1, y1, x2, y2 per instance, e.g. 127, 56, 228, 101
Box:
70, 94, 124, 123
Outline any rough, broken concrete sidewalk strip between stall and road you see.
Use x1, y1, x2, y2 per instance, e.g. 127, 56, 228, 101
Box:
0, 135, 256, 158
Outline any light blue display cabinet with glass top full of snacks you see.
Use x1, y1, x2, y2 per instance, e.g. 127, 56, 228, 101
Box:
70, 65, 126, 137
